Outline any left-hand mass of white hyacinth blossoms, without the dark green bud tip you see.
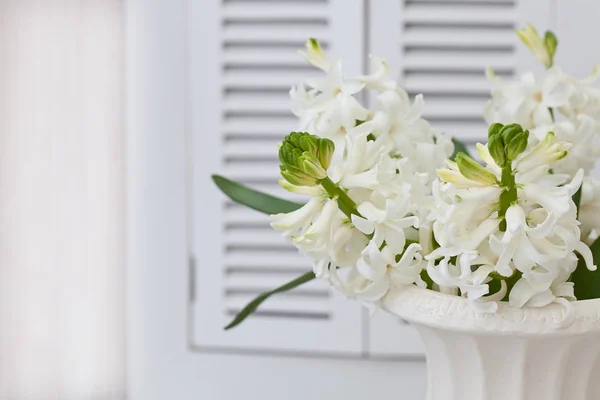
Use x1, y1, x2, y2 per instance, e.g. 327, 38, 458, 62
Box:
271, 40, 454, 301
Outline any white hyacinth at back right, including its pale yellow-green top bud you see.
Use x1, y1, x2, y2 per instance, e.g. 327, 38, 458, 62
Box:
484, 26, 600, 253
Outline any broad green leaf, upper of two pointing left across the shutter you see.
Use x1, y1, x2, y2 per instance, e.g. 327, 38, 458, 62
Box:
212, 175, 302, 214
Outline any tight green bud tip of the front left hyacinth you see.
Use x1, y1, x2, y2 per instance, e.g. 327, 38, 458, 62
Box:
279, 132, 335, 186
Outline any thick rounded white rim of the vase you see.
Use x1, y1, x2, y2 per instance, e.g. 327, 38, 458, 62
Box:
381, 285, 600, 336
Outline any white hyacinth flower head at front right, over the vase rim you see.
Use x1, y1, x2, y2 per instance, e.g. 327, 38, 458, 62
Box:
426, 133, 595, 318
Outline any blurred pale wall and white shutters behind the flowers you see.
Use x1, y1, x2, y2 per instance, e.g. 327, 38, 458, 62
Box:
0, 0, 600, 400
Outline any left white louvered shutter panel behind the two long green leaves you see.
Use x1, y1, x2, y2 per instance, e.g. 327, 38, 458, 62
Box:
189, 0, 363, 354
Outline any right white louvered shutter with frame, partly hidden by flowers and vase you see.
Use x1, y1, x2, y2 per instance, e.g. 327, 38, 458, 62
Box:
369, 0, 550, 357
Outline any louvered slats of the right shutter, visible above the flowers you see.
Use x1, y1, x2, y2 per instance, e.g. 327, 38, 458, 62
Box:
400, 0, 518, 143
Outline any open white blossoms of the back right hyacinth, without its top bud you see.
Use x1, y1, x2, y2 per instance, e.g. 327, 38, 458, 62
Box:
484, 66, 600, 175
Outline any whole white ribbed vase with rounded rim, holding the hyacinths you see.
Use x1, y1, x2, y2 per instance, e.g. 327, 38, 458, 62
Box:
383, 286, 600, 400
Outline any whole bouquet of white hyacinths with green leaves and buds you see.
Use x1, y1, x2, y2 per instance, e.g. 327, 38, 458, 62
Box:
214, 26, 600, 328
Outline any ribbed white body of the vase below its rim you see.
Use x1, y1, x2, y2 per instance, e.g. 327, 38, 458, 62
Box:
418, 326, 600, 400
